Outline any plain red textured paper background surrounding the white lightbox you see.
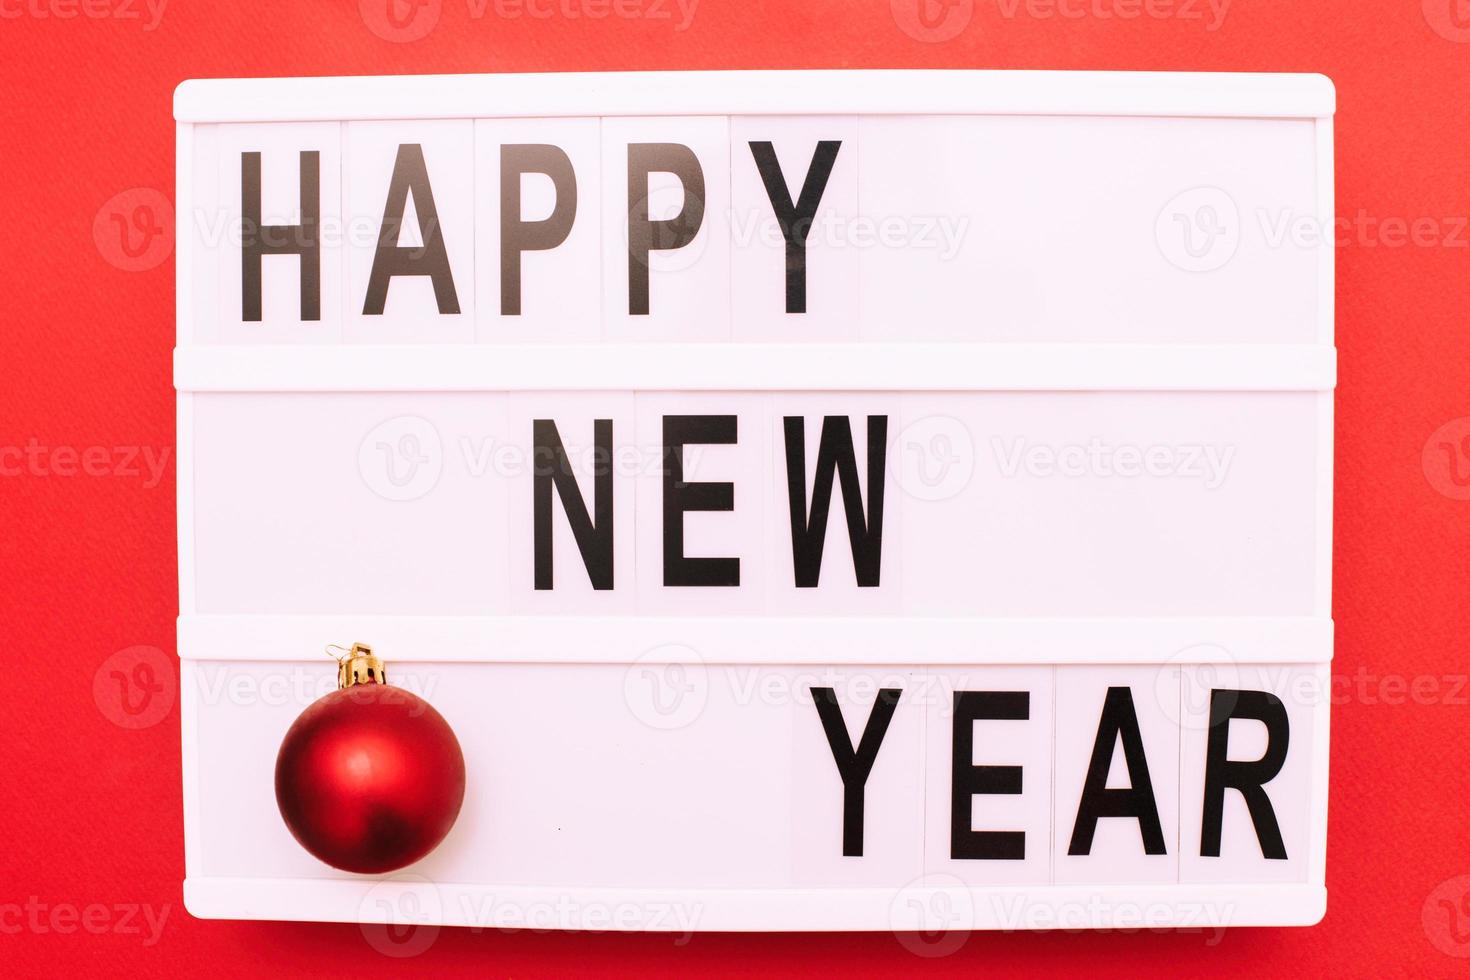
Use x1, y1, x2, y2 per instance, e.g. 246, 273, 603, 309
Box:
0, 0, 1470, 977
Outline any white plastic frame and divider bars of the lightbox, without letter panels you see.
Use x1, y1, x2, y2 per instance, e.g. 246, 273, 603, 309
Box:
173, 71, 1336, 930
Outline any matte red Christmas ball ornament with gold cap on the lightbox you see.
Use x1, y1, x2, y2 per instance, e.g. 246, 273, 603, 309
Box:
275, 644, 465, 874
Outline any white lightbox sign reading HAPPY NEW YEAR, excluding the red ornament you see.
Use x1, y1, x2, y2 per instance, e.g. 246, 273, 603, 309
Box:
175, 71, 1336, 932
